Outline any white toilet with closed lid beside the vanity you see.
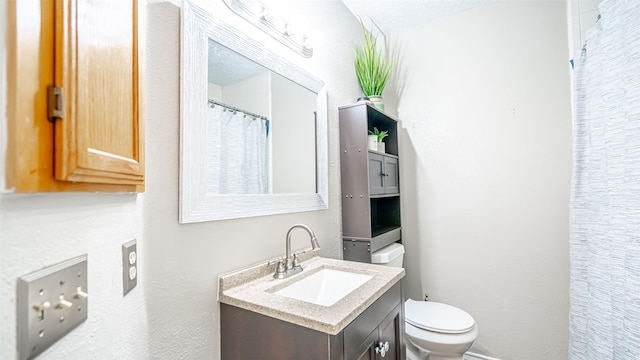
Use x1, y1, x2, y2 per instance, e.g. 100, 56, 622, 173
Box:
371, 243, 478, 360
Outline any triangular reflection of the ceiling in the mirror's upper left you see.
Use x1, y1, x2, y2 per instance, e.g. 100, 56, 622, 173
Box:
209, 40, 268, 85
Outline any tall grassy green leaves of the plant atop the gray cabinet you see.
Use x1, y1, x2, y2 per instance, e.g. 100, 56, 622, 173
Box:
355, 19, 391, 96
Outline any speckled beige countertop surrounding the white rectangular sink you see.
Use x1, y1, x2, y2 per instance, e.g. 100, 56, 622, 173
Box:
218, 251, 405, 335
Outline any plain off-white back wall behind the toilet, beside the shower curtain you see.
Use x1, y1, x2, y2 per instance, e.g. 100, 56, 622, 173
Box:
391, 1, 571, 360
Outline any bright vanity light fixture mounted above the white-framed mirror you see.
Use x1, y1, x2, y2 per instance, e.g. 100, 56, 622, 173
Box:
223, 0, 324, 58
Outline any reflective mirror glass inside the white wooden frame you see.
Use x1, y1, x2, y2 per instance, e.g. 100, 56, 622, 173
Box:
206, 39, 317, 194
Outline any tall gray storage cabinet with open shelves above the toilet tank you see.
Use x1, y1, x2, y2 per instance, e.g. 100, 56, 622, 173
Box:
339, 103, 401, 262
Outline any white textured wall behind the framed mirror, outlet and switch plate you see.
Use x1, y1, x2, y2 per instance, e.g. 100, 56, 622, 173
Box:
0, 0, 360, 360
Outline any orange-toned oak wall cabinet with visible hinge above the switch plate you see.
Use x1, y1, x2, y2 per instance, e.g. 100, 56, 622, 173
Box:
4, 0, 144, 192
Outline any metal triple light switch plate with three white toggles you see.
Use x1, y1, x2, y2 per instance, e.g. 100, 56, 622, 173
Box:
17, 254, 89, 360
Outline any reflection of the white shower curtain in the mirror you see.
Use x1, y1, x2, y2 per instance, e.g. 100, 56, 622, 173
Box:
206, 105, 269, 194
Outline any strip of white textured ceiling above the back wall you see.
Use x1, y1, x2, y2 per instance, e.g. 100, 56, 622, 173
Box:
342, 0, 494, 34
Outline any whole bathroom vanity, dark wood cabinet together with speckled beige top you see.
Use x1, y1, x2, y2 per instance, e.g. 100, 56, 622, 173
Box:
219, 254, 405, 360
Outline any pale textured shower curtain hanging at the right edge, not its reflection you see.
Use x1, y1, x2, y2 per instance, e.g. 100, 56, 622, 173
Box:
569, 0, 640, 360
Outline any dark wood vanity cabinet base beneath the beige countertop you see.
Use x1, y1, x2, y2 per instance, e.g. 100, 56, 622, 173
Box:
220, 282, 405, 360
